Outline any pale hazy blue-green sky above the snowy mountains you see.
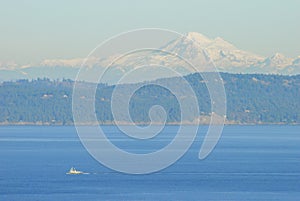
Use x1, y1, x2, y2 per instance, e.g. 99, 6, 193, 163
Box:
0, 0, 300, 64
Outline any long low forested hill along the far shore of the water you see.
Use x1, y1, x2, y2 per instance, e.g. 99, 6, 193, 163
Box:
0, 73, 300, 125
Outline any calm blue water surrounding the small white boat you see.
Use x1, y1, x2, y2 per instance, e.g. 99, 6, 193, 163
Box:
0, 126, 300, 201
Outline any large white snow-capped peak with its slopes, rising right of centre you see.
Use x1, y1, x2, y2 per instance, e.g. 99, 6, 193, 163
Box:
92, 32, 300, 74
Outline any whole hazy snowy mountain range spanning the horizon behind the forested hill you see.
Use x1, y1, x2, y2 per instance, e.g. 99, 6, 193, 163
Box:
0, 32, 300, 83
